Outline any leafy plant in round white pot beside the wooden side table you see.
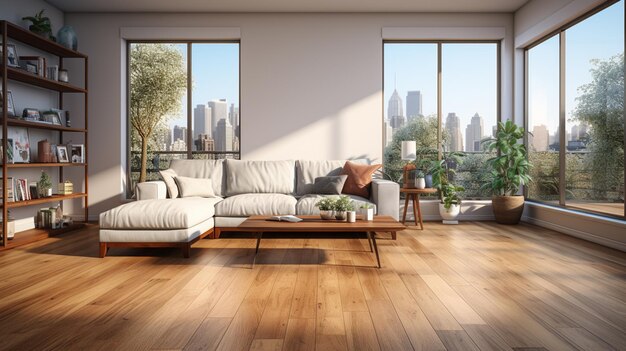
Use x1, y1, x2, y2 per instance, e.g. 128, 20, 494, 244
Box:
429, 147, 465, 221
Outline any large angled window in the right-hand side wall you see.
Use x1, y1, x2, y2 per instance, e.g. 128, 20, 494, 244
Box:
526, 0, 625, 217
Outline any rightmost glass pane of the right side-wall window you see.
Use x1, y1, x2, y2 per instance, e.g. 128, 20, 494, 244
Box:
565, 1, 624, 216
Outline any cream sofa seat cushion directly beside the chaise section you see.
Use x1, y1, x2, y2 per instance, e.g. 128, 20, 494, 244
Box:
215, 194, 296, 217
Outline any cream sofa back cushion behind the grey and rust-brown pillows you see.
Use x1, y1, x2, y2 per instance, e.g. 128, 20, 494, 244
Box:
296, 159, 368, 196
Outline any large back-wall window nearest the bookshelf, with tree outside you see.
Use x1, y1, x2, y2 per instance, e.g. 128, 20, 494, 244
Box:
128, 42, 241, 195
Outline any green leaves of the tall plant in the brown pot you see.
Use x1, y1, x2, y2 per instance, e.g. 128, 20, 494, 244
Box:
483, 120, 532, 196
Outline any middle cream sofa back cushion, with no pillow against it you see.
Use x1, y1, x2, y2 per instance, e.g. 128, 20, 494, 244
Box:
226, 159, 295, 196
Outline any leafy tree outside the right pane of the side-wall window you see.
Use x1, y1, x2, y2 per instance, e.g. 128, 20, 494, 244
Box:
573, 53, 624, 201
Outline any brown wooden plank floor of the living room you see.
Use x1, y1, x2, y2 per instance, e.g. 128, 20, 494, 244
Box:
0, 222, 626, 350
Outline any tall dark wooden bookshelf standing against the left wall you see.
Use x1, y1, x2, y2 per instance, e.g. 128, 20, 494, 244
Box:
0, 21, 89, 250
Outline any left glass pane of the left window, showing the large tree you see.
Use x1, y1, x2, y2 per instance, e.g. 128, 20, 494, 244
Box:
128, 43, 187, 189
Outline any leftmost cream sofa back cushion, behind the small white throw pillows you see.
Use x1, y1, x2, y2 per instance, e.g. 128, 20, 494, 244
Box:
170, 159, 225, 196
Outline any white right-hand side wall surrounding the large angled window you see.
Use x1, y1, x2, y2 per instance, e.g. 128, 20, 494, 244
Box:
514, 0, 626, 251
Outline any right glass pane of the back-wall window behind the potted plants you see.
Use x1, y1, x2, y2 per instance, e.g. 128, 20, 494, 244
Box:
441, 43, 498, 199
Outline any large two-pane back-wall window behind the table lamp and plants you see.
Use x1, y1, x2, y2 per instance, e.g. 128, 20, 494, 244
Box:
383, 42, 500, 199
